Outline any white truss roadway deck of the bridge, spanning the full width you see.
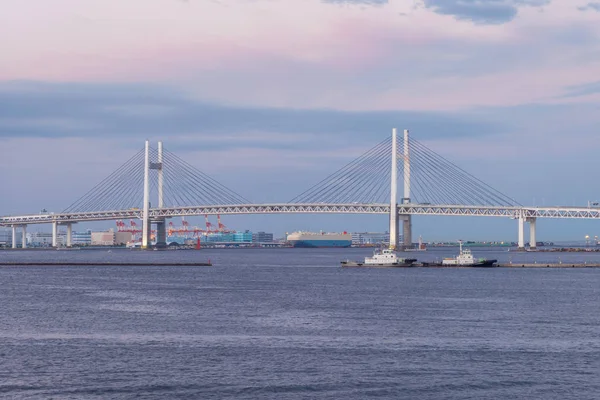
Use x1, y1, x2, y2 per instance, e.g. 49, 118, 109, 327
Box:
0, 203, 600, 226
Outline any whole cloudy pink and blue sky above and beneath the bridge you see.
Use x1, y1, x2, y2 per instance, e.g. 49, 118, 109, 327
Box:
0, 0, 600, 241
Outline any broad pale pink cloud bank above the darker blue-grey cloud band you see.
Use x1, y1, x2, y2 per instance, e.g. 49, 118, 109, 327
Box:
0, 0, 600, 109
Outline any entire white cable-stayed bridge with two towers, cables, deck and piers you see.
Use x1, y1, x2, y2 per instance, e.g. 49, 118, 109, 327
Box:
0, 129, 600, 248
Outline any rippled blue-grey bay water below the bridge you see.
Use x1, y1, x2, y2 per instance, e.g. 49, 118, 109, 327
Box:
0, 249, 600, 399
